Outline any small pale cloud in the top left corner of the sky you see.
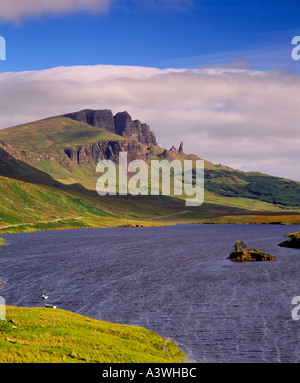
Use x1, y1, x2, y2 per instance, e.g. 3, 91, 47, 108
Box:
0, 0, 114, 21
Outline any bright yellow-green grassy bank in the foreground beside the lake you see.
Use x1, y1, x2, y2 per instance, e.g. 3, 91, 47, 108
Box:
0, 306, 185, 363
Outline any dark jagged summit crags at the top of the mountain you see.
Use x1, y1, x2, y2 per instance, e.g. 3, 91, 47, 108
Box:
63, 109, 157, 146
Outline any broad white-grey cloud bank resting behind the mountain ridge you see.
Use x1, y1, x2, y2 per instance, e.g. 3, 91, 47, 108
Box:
0, 65, 300, 181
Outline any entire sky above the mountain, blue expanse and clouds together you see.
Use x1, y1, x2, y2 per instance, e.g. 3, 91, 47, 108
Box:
0, 0, 300, 181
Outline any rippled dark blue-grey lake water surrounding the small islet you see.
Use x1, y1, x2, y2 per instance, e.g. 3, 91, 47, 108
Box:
0, 225, 300, 363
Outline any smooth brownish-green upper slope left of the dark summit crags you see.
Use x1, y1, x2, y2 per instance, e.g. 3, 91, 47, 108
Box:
0, 117, 125, 155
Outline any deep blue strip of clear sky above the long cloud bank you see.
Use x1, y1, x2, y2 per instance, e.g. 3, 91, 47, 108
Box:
0, 0, 300, 73
